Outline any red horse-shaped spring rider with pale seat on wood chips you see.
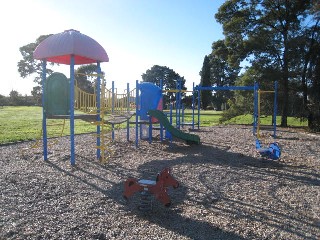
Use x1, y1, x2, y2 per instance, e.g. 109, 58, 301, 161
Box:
123, 167, 179, 211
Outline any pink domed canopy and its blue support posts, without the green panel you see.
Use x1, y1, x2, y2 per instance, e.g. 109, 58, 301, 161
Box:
33, 29, 109, 165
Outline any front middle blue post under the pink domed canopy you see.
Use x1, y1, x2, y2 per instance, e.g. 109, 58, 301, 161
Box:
70, 55, 76, 166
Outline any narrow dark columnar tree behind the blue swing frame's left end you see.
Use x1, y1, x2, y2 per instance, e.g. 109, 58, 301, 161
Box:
199, 55, 212, 109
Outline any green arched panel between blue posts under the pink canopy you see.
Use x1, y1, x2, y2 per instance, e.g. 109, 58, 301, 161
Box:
44, 72, 70, 115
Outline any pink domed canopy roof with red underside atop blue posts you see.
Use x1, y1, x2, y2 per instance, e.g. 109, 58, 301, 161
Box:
33, 29, 109, 65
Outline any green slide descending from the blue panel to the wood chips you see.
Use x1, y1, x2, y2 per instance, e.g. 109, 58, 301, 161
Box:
148, 110, 200, 144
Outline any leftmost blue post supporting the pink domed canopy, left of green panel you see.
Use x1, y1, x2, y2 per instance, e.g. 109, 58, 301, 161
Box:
42, 60, 48, 161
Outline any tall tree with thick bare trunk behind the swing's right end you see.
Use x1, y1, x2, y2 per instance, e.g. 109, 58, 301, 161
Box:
215, 0, 312, 126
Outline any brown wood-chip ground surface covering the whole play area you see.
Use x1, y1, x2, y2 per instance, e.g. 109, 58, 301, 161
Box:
0, 125, 320, 239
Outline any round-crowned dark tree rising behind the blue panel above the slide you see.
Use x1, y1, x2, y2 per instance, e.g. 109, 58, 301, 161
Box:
142, 65, 186, 106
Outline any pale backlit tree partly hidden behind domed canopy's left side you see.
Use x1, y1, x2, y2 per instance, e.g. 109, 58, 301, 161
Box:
17, 34, 54, 85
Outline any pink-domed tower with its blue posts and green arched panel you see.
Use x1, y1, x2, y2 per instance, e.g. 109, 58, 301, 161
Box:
33, 29, 109, 165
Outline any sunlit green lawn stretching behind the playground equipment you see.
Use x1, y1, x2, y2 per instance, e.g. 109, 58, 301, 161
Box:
0, 107, 307, 144
